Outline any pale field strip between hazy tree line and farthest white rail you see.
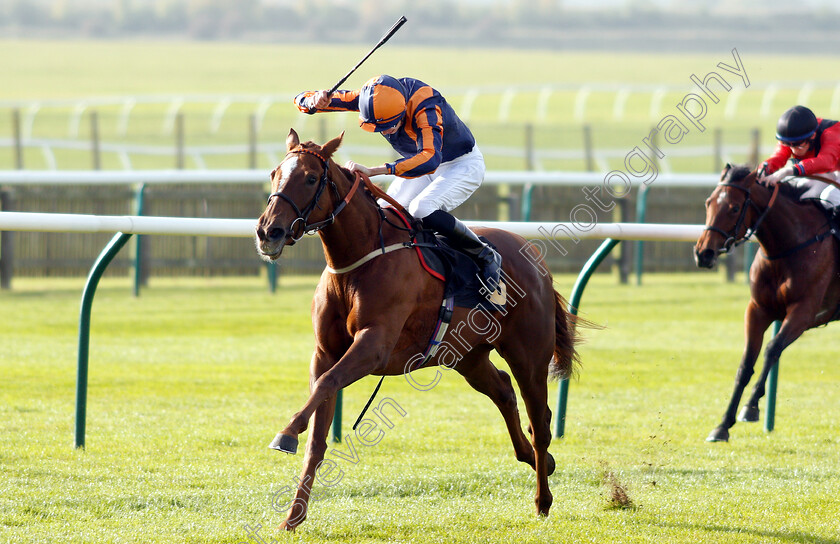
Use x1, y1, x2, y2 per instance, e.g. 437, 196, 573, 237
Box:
0, 40, 840, 100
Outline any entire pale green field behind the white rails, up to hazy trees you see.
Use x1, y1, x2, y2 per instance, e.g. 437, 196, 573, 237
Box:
0, 40, 840, 171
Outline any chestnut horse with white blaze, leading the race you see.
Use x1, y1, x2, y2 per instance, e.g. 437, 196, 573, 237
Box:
256, 130, 578, 530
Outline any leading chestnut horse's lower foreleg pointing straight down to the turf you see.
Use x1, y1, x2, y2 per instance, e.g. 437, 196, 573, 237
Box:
273, 396, 336, 531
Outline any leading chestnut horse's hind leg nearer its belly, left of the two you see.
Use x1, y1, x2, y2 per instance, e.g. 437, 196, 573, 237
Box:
455, 348, 540, 470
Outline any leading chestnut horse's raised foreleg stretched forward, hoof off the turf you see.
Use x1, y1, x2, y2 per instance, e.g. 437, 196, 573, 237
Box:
270, 328, 396, 453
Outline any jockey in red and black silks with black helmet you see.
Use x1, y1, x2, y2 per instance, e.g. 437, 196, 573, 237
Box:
759, 106, 840, 185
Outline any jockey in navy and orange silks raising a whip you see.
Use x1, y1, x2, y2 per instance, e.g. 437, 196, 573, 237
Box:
294, 75, 502, 293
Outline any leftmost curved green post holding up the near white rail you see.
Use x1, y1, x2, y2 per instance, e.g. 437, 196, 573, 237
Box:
76, 232, 131, 448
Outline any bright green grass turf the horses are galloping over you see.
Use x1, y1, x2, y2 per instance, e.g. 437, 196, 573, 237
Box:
0, 272, 840, 544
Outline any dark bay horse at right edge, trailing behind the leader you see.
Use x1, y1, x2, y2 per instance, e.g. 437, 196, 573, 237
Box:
694, 165, 840, 442
